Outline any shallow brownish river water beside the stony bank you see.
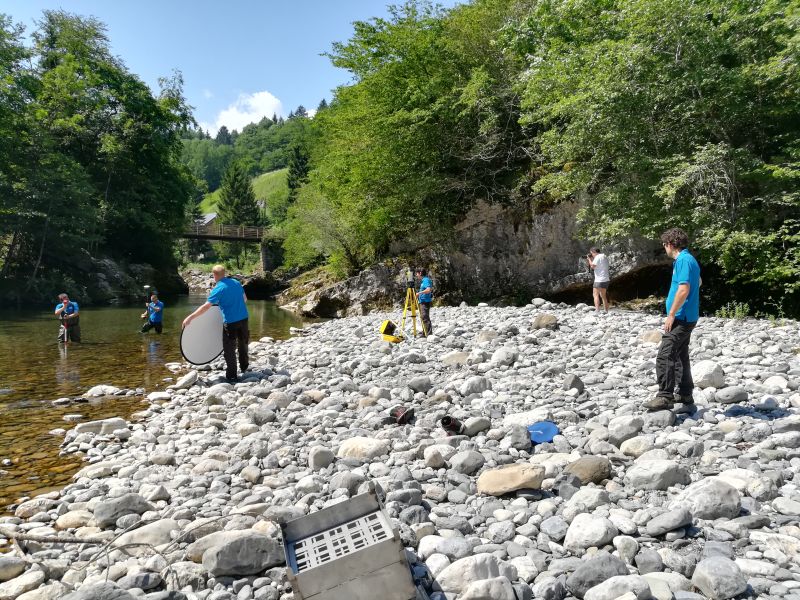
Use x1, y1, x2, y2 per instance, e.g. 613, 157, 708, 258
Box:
0, 296, 303, 512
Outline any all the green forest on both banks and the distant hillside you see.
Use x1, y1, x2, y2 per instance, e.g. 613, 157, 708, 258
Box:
0, 0, 800, 315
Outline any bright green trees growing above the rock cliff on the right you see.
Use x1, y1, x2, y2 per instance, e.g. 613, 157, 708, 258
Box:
286, 0, 800, 314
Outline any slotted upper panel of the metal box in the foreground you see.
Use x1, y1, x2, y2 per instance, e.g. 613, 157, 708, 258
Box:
290, 511, 393, 573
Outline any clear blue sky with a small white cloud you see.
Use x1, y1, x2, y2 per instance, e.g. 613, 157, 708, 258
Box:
0, 0, 460, 133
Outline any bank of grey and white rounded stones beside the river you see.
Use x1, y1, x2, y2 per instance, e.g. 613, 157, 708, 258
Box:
0, 299, 800, 600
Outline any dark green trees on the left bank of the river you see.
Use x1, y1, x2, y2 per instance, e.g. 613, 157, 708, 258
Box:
0, 11, 195, 304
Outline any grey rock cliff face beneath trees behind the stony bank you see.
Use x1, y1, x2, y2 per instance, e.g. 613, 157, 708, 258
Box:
278, 203, 668, 317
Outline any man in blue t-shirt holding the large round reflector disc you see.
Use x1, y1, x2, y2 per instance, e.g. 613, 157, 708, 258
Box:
183, 265, 250, 381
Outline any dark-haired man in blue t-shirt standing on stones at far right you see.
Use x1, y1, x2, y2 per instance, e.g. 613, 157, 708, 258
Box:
645, 228, 701, 413
